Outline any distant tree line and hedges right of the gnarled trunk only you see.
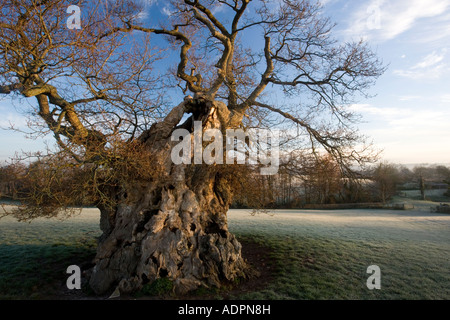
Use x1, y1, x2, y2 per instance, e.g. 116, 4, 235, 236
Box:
230, 154, 450, 208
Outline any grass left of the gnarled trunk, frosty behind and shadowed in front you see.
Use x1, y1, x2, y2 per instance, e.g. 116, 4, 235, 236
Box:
0, 208, 101, 299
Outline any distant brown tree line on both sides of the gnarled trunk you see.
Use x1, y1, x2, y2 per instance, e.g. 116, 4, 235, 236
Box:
0, 154, 450, 208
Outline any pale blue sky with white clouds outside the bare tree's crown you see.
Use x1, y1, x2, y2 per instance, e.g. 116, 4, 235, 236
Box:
0, 0, 450, 164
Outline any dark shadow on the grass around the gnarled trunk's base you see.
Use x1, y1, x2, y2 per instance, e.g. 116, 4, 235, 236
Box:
0, 239, 275, 300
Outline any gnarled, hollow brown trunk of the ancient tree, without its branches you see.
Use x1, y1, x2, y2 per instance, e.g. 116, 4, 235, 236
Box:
90, 98, 249, 294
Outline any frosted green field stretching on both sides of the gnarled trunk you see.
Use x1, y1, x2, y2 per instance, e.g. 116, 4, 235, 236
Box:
0, 204, 450, 299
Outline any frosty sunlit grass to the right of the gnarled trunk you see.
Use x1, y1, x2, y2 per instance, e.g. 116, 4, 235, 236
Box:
229, 210, 450, 299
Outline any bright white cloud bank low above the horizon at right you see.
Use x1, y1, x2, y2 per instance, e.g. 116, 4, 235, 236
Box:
350, 102, 450, 163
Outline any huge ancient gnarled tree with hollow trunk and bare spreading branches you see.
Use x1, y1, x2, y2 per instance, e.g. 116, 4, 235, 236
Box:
0, 0, 384, 294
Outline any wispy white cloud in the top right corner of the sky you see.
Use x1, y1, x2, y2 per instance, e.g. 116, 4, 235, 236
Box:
346, 0, 450, 41
